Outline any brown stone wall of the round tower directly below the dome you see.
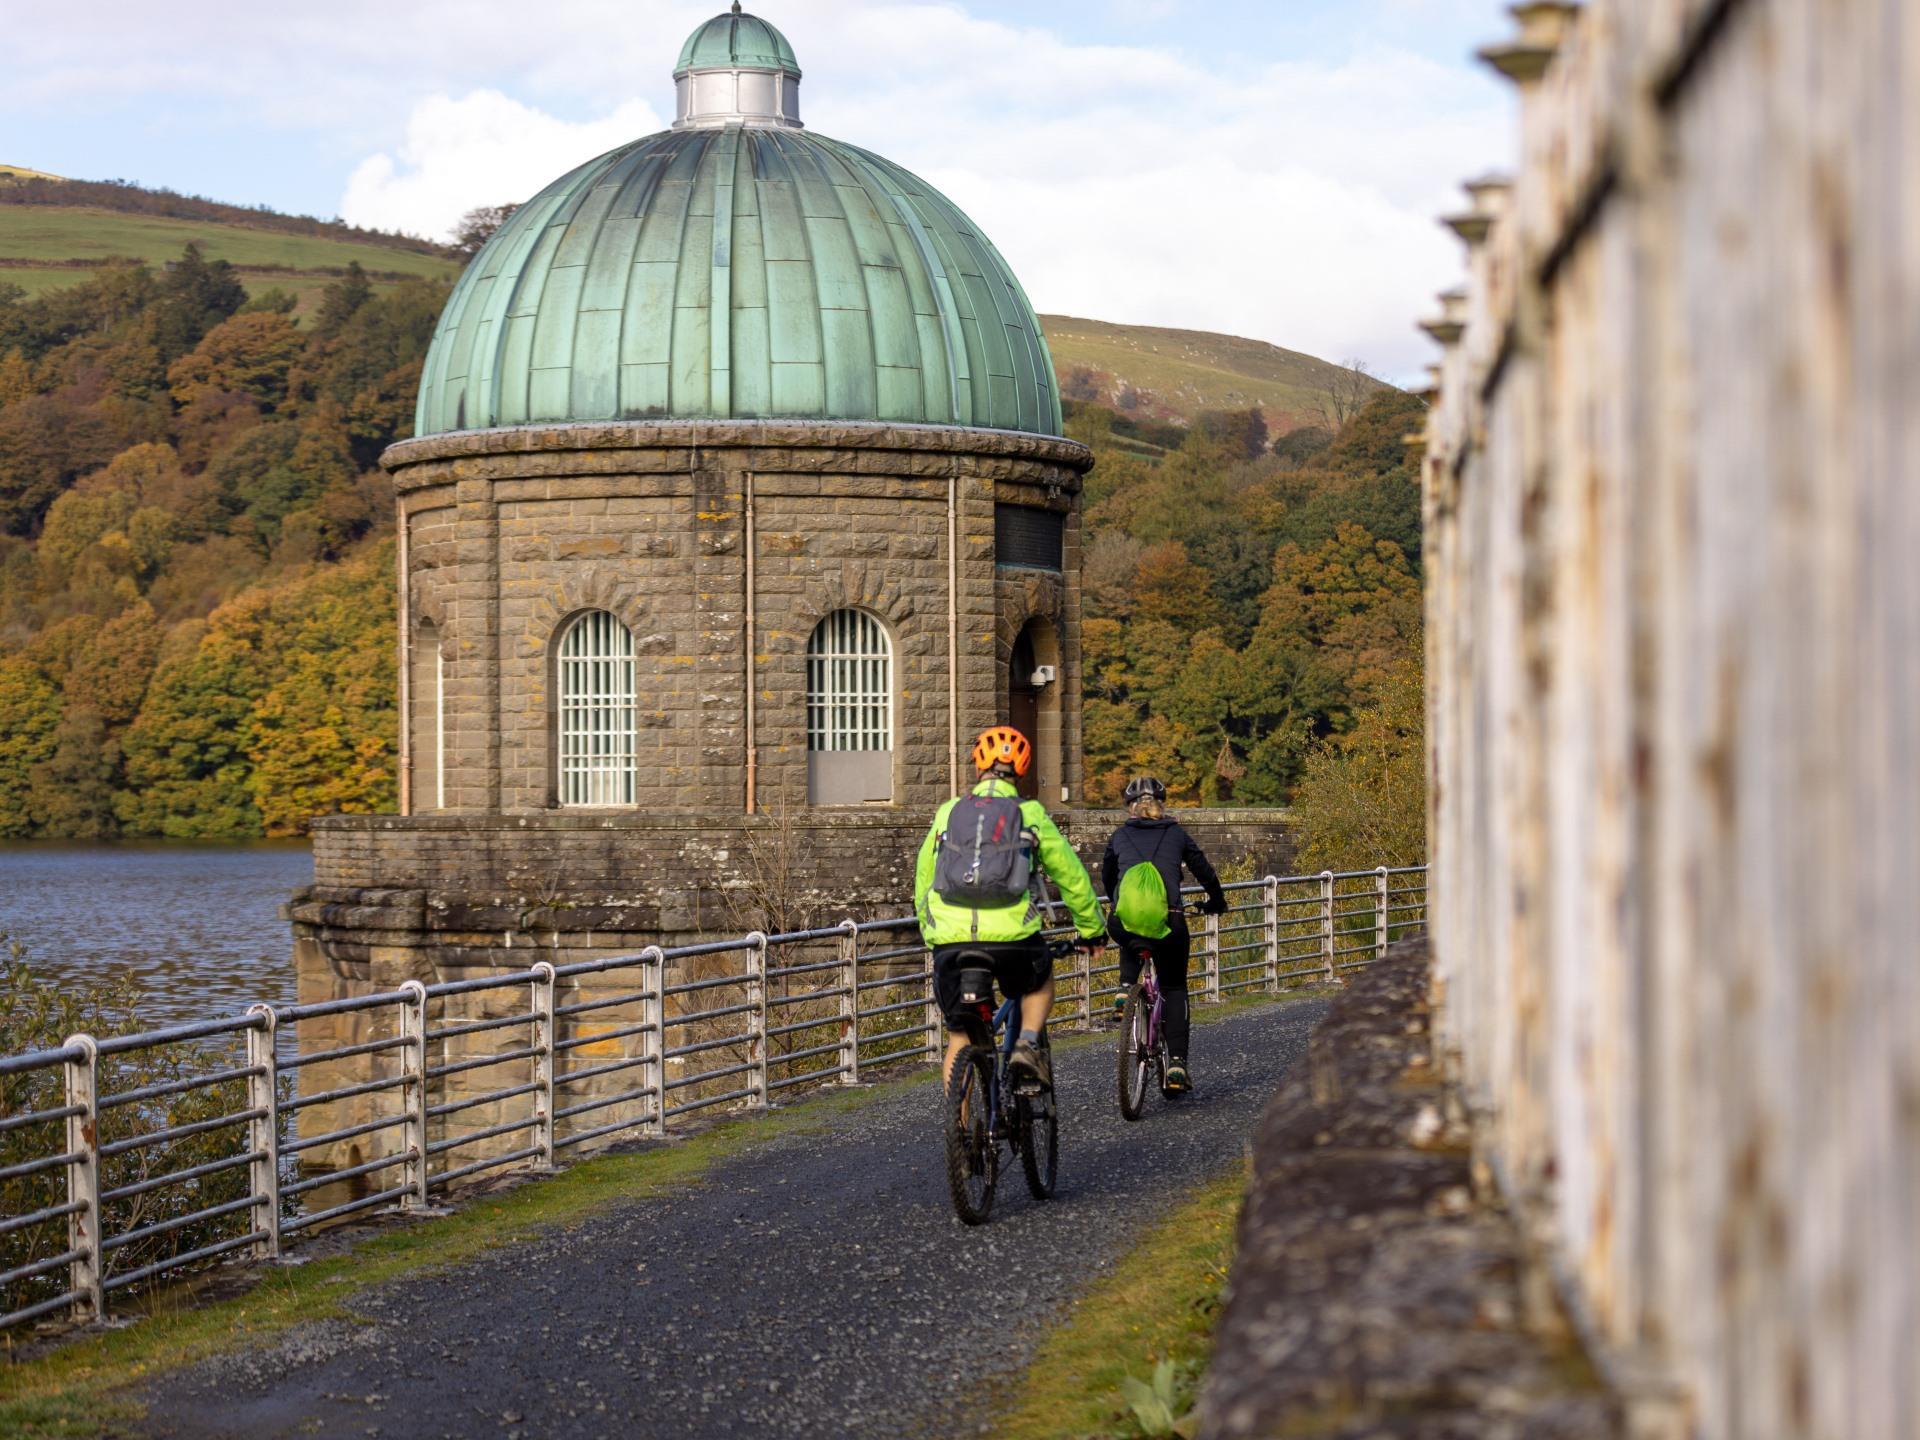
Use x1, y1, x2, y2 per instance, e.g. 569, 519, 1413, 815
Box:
386, 422, 1091, 814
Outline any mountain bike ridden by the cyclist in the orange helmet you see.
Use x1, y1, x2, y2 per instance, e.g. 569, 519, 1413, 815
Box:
945, 941, 1075, 1225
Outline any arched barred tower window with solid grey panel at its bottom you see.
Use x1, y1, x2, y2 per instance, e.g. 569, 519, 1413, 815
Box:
806, 611, 893, 804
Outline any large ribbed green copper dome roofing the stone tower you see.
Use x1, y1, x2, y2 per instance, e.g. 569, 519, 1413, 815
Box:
415, 125, 1062, 436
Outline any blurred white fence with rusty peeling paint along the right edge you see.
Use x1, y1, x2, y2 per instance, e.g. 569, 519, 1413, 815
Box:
1425, 0, 1920, 1440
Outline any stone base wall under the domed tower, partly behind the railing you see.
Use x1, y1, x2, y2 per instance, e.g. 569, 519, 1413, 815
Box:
288, 806, 1292, 1198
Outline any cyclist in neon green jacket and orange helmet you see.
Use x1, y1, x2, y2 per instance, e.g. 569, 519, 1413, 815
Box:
914, 726, 1106, 1085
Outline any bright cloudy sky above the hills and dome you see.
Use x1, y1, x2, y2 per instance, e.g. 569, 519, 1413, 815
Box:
11, 0, 1511, 378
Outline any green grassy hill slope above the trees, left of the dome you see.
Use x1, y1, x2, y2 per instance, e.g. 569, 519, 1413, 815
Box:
0, 205, 459, 313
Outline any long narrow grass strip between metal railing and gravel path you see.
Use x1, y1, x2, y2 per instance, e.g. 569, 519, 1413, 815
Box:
0, 1069, 933, 1440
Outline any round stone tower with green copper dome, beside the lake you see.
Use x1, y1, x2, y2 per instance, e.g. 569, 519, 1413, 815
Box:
292, 6, 1273, 977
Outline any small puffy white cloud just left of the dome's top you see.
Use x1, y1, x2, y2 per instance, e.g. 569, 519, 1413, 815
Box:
340, 90, 660, 238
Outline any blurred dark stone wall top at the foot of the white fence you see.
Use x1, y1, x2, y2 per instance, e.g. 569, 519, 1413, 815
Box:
1198, 941, 1624, 1440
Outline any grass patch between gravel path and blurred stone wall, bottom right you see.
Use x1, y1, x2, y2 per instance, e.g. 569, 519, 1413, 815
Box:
993, 1165, 1246, 1440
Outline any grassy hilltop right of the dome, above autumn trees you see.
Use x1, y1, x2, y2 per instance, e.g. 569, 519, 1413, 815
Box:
1041, 315, 1374, 434
